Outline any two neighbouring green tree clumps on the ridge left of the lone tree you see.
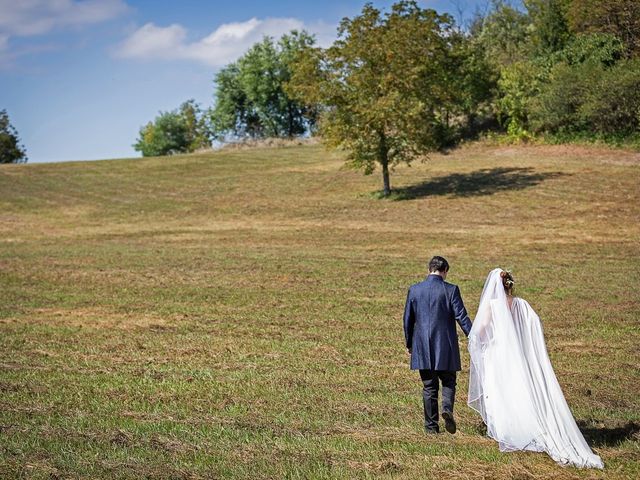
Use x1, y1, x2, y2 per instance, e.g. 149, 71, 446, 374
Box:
134, 31, 317, 156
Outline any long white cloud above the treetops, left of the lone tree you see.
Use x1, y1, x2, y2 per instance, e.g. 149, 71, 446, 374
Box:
114, 17, 335, 66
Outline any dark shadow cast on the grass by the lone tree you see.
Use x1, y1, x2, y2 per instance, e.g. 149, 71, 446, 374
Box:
392, 167, 567, 200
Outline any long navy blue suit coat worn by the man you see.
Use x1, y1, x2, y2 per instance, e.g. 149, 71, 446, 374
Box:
404, 275, 471, 371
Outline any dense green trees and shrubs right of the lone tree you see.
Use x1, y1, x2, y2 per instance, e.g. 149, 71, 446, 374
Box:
470, 0, 640, 144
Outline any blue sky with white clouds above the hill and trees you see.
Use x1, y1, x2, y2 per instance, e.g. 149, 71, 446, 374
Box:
0, 0, 488, 163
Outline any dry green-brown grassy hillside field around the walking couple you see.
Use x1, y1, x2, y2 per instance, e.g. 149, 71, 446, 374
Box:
0, 141, 640, 479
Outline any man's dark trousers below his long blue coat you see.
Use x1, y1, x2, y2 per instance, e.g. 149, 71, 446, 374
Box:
420, 370, 456, 432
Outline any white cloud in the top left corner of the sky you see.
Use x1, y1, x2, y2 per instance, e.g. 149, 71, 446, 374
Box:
0, 0, 129, 36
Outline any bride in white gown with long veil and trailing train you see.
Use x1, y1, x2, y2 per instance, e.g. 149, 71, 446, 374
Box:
468, 268, 604, 468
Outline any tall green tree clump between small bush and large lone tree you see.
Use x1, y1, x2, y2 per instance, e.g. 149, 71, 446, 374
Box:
210, 30, 315, 140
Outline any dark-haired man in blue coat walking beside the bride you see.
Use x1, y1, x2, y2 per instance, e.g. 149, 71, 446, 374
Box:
404, 256, 471, 433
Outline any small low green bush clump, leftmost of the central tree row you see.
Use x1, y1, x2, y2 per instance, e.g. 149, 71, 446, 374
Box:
133, 100, 211, 157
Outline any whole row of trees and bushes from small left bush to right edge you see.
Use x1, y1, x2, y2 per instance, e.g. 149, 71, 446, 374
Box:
136, 0, 640, 196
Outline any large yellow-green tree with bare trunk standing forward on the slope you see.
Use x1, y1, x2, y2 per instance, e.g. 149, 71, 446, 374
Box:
288, 1, 453, 196
